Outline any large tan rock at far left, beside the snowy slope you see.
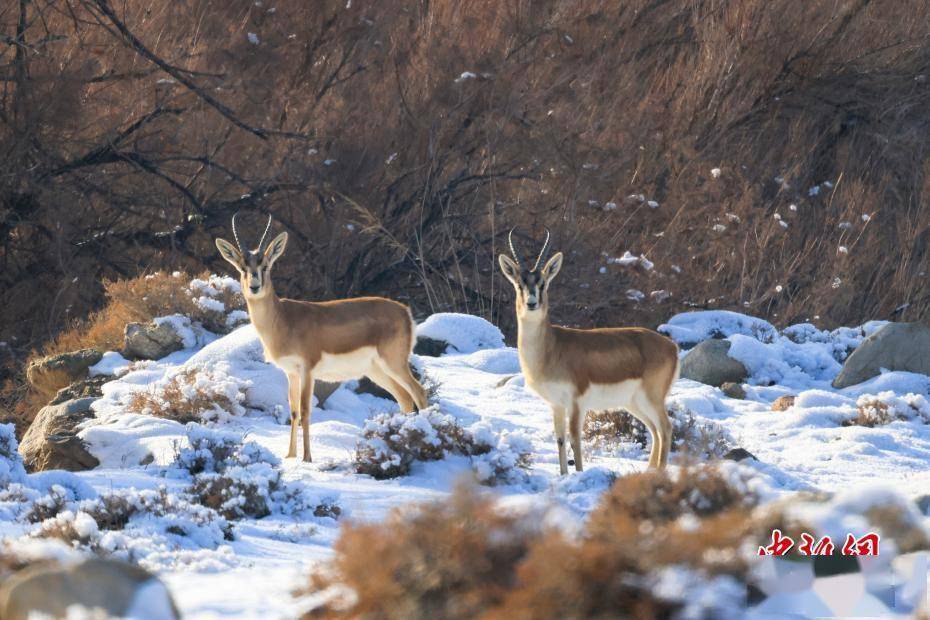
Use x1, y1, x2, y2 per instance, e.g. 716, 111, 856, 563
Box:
19, 398, 100, 471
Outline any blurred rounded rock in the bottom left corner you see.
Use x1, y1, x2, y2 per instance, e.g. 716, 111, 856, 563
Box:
0, 558, 180, 620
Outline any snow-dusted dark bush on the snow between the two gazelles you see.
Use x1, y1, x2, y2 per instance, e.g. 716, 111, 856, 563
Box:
355, 405, 531, 483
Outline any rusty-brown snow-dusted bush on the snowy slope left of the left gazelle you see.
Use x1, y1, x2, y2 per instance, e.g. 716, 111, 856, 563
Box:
126, 368, 240, 424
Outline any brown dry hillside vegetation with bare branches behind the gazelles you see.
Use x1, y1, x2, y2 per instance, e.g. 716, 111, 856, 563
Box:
0, 0, 930, 368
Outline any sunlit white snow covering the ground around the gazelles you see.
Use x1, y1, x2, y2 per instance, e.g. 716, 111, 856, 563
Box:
0, 304, 930, 618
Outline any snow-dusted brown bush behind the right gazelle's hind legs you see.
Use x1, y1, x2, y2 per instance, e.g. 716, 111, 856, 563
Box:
584, 404, 732, 459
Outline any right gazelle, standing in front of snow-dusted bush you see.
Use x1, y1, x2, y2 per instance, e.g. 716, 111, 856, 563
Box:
498, 230, 678, 475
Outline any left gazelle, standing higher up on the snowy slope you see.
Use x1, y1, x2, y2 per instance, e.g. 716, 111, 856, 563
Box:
216, 214, 426, 462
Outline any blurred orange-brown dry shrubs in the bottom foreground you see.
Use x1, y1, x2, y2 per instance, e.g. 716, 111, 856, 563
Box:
308, 469, 754, 618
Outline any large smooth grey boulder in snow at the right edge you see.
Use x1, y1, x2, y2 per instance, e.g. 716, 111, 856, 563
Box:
833, 323, 930, 388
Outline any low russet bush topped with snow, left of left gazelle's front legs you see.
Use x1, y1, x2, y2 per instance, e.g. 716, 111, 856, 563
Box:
126, 368, 245, 423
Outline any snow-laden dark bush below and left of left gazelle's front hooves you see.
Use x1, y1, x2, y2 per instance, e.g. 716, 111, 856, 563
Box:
169, 424, 339, 520
